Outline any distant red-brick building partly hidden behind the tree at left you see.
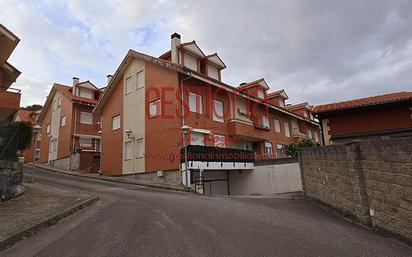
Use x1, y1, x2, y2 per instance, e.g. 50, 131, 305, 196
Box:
15, 108, 41, 163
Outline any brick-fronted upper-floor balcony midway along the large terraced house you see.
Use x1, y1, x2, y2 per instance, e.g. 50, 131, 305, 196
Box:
228, 119, 270, 141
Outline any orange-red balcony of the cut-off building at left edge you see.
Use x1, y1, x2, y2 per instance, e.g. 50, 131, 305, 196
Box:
0, 88, 21, 122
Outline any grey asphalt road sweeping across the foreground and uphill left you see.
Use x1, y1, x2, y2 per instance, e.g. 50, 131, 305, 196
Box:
0, 166, 412, 257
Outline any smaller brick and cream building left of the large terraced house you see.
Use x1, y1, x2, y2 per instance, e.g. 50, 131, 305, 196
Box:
39, 77, 104, 172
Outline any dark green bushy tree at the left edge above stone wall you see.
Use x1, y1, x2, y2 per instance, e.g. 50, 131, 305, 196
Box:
0, 121, 33, 160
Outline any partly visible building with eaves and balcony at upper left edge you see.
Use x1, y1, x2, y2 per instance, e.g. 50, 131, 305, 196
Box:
0, 24, 21, 124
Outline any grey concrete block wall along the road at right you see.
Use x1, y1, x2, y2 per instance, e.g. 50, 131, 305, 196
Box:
299, 137, 412, 240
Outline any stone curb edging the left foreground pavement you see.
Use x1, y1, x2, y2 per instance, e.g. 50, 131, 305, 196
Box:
0, 196, 99, 252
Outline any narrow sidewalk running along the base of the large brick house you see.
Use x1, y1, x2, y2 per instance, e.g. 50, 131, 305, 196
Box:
36, 163, 187, 191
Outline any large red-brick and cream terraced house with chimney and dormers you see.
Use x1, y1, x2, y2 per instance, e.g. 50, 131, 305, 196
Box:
94, 33, 319, 185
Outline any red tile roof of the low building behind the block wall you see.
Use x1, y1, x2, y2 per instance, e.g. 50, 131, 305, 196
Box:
313, 91, 412, 114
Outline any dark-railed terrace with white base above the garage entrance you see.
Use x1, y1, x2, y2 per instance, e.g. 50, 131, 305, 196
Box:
180, 145, 255, 170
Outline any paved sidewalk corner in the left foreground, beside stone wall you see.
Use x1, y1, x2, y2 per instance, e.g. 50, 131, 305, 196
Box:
0, 183, 98, 251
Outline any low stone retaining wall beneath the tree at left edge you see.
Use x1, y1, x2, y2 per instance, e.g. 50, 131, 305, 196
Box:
0, 160, 24, 201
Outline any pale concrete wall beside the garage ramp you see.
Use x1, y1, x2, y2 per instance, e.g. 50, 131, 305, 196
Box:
229, 163, 302, 195
